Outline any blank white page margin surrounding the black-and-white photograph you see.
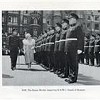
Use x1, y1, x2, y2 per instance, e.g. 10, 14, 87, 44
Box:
0, 0, 100, 100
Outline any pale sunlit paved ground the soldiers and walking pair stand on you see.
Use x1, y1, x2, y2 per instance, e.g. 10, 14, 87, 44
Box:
2, 56, 100, 86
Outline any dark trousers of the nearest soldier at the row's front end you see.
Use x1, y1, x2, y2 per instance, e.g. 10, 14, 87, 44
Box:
66, 50, 78, 81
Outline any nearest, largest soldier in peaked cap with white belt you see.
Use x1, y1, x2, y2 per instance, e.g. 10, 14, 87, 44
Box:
65, 13, 84, 83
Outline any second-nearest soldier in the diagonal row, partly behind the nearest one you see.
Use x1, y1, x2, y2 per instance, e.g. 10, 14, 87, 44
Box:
58, 19, 69, 78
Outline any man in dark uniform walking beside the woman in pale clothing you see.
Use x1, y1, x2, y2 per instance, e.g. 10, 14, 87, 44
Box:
9, 29, 21, 70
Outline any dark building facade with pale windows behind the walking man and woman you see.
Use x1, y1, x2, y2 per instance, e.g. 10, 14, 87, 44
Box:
2, 11, 43, 48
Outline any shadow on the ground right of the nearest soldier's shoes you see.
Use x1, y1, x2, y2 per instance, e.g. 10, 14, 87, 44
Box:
77, 74, 100, 85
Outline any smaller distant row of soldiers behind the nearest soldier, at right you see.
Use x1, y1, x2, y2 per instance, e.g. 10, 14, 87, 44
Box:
81, 33, 100, 67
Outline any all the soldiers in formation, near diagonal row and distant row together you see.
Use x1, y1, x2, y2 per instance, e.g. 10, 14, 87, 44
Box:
35, 13, 100, 83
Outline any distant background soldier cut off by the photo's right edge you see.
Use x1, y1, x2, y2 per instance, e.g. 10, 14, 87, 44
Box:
94, 34, 100, 67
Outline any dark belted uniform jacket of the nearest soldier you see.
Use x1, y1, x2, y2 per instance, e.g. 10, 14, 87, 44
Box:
65, 26, 84, 52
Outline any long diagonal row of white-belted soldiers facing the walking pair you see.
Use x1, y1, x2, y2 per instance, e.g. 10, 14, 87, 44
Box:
35, 13, 84, 83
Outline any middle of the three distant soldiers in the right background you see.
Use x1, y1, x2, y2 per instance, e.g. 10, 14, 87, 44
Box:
89, 34, 95, 66
